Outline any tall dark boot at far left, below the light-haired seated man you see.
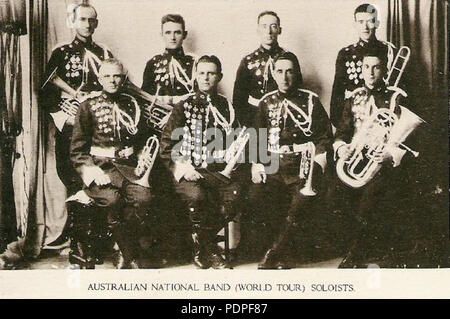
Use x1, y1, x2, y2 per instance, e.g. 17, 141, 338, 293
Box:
67, 202, 95, 269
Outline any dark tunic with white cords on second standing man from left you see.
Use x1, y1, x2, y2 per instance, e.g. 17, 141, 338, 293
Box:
142, 48, 195, 105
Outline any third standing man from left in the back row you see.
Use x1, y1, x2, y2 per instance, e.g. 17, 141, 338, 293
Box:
233, 11, 302, 127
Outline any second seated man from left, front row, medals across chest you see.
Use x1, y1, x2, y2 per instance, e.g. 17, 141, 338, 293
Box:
161, 55, 239, 268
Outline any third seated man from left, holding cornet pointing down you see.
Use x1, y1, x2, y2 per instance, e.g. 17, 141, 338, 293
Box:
248, 52, 331, 269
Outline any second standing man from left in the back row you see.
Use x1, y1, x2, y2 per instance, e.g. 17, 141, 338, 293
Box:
142, 14, 195, 130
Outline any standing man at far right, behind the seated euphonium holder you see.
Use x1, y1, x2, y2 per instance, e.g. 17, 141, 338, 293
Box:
330, 4, 395, 127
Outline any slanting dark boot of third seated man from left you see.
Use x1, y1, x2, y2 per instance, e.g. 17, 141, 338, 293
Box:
258, 217, 294, 269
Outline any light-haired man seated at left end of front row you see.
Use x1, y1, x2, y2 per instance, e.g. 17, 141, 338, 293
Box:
70, 59, 152, 268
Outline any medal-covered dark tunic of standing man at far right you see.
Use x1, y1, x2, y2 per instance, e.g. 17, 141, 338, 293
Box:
330, 38, 395, 127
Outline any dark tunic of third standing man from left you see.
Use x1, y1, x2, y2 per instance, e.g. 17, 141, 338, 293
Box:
233, 45, 302, 127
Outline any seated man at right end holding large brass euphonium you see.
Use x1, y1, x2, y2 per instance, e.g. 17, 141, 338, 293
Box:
333, 48, 422, 267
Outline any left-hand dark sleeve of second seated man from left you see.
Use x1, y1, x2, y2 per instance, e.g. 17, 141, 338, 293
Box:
159, 101, 185, 170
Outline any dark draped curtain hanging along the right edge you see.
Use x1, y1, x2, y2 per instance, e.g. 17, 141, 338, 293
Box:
387, 0, 449, 260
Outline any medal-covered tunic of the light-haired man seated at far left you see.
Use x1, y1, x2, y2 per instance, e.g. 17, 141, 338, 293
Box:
71, 92, 148, 187
